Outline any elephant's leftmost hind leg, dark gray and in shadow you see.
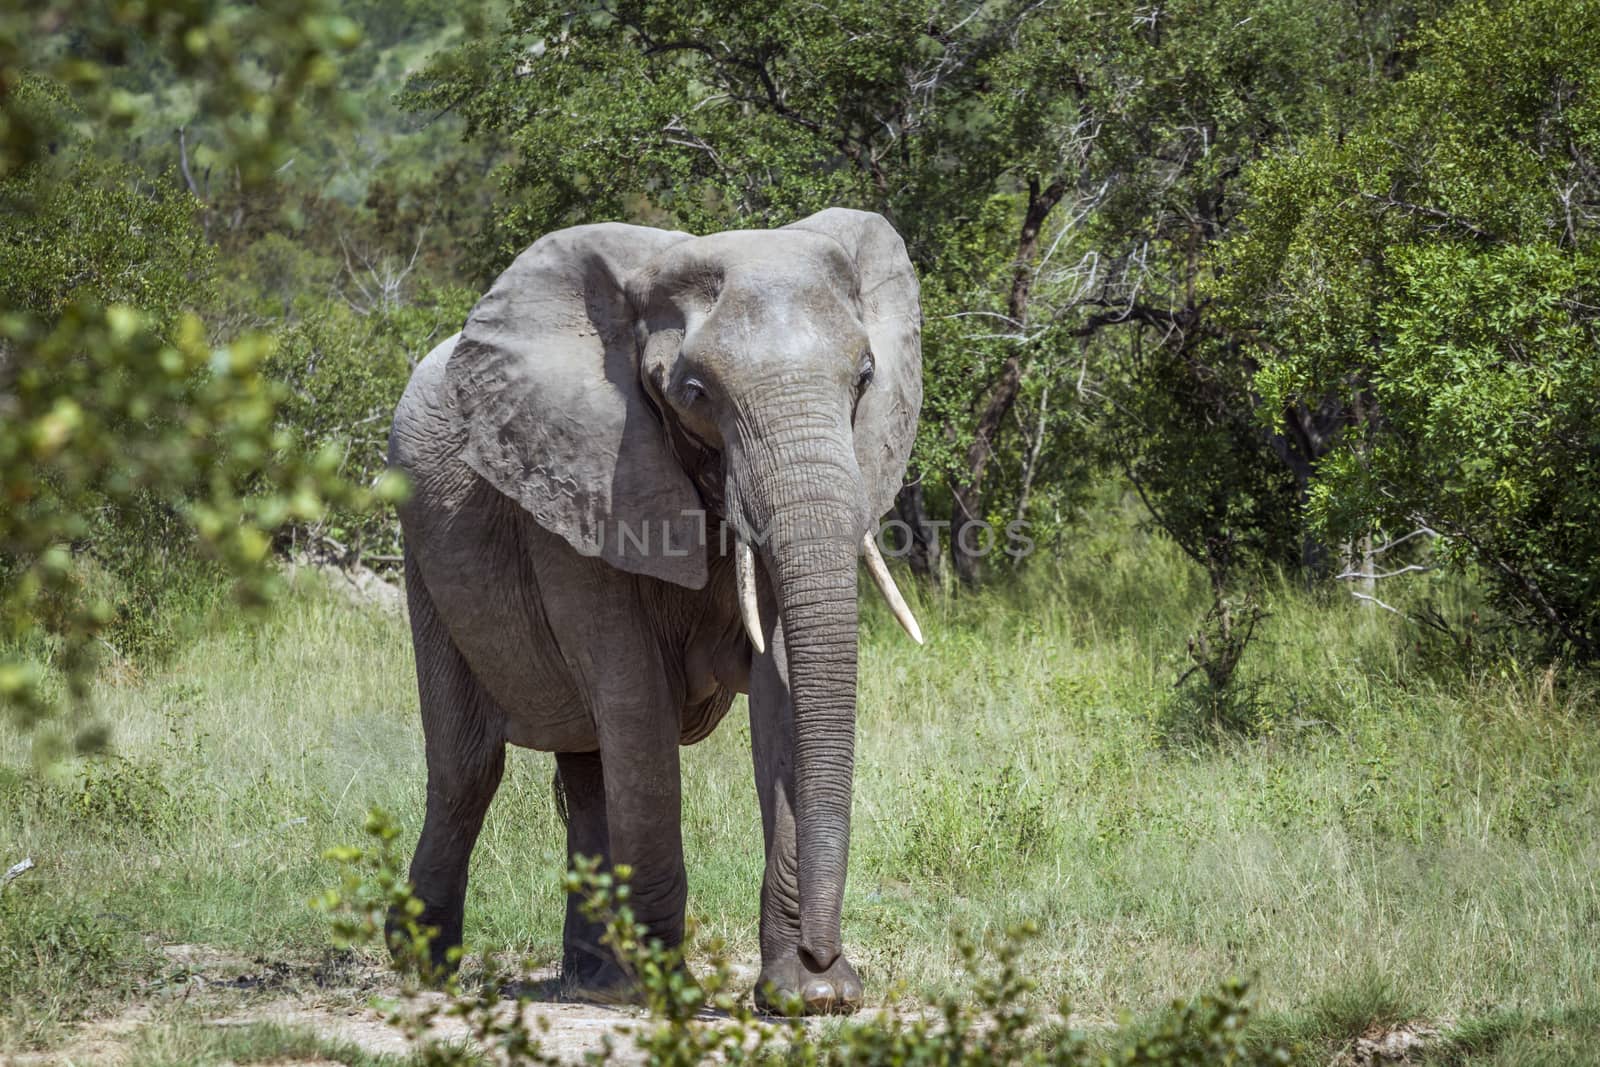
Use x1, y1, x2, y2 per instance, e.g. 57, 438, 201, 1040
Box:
396, 558, 506, 966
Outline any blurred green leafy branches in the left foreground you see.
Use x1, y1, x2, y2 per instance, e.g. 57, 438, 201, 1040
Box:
0, 0, 393, 749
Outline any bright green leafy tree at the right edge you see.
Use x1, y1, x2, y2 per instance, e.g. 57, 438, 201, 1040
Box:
1216, 0, 1600, 661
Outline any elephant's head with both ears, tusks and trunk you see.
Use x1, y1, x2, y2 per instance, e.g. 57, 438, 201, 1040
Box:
446, 208, 922, 966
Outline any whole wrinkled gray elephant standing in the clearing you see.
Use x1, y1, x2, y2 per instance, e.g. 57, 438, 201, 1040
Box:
379, 210, 922, 1011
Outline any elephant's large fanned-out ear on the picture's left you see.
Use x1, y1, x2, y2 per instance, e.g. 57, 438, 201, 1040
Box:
445, 222, 706, 589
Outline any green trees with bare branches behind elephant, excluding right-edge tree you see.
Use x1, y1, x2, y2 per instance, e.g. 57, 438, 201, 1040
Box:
408, 0, 1440, 579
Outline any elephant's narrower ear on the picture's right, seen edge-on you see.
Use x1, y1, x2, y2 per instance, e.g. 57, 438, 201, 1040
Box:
786, 208, 922, 518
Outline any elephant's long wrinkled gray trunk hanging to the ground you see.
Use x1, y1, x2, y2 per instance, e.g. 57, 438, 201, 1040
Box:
741, 406, 867, 969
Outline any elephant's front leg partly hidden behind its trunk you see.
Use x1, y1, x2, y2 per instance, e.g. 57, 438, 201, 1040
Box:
750, 617, 862, 1014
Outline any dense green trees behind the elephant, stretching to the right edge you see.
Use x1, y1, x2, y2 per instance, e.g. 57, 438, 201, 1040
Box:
393, 0, 1600, 659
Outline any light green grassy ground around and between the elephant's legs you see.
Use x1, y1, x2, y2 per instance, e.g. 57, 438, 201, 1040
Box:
0, 505, 1600, 1064
